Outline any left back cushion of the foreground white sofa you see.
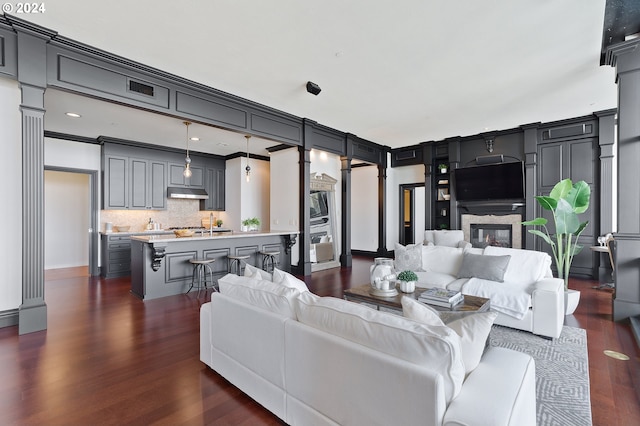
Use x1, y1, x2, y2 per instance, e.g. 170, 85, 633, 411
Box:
218, 274, 300, 319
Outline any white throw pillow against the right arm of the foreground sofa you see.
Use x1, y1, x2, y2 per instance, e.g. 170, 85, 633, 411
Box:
447, 312, 498, 374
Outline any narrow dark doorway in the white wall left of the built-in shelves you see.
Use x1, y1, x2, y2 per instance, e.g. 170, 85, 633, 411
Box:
398, 183, 426, 245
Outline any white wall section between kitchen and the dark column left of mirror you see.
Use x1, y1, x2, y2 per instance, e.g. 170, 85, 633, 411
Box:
269, 148, 300, 265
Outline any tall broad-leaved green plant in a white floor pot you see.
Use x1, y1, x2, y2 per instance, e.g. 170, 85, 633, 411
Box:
522, 179, 591, 315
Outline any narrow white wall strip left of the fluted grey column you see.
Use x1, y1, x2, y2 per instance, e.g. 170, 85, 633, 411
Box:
0, 78, 22, 312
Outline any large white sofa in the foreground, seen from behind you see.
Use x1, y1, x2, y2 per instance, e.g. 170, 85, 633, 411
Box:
200, 273, 536, 426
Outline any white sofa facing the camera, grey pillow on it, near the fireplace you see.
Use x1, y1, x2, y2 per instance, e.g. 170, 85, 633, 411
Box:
395, 244, 564, 338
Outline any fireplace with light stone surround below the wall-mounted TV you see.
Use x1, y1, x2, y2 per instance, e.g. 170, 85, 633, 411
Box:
461, 214, 522, 248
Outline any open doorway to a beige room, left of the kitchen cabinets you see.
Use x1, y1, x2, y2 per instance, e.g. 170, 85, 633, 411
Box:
44, 166, 100, 276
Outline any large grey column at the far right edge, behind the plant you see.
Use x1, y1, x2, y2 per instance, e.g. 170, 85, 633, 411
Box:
603, 39, 640, 321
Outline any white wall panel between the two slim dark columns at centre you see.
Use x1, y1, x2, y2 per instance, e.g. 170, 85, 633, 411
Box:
351, 165, 379, 252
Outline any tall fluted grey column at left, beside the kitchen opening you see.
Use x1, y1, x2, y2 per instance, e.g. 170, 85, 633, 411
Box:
13, 18, 54, 334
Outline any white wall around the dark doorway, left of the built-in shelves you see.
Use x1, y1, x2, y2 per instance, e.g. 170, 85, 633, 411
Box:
387, 154, 424, 250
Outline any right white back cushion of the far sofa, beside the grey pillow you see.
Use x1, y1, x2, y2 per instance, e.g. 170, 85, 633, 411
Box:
484, 246, 551, 284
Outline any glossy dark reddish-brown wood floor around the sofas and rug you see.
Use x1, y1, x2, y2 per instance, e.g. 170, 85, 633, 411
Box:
0, 258, 640, 426
